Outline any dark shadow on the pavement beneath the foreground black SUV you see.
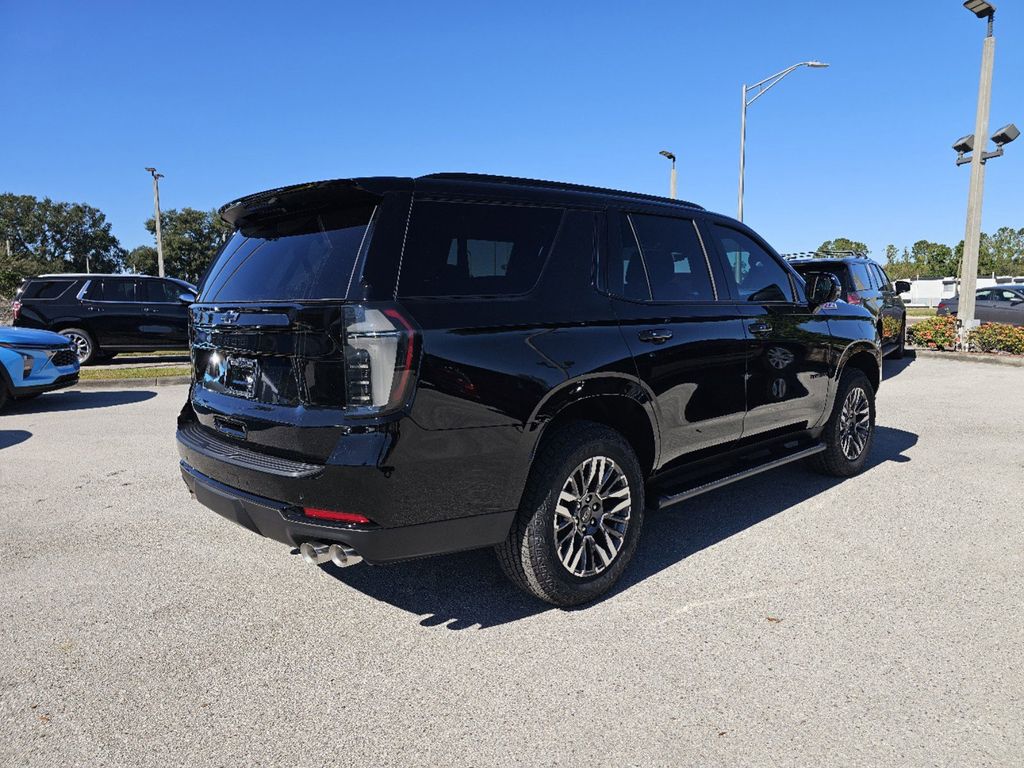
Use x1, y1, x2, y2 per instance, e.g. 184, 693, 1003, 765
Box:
319, 427, 918, 630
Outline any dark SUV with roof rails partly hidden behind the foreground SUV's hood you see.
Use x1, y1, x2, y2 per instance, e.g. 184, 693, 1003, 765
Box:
788, 253, 910, 359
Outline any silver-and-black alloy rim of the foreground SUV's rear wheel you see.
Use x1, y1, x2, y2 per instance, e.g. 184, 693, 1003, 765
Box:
554, 456, 632, 578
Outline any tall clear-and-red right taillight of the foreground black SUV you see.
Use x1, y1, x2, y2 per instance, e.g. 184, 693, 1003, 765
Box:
344, 304, 417, 414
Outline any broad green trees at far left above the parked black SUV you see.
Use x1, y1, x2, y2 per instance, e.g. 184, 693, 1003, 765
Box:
0, 193, 124, 292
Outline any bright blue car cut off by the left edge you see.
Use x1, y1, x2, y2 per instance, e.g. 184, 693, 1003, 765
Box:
0, 328, 78, 411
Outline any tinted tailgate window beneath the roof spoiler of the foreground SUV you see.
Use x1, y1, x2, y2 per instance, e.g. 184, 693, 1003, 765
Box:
200, 206, 376, 301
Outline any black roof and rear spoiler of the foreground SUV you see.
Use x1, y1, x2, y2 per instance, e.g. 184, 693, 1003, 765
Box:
220, 173, 705, 226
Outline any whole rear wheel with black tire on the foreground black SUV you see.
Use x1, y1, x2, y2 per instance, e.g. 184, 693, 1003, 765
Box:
495, 421, 644, 606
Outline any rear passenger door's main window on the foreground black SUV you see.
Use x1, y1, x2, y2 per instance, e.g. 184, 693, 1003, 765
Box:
629, 214, 715, 301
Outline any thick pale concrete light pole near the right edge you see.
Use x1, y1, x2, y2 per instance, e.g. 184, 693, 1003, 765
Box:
956, 0, 995, 345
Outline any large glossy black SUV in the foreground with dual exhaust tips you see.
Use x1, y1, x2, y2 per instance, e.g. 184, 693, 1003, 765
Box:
177, 174, 882, 605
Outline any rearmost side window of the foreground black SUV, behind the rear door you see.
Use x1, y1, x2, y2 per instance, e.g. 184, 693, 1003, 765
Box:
399, 201, 562, 296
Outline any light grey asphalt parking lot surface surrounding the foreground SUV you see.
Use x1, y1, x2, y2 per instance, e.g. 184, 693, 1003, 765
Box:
0, 357, 1024, 766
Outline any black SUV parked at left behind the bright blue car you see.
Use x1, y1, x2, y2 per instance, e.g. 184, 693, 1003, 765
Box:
11, 274, 197, 366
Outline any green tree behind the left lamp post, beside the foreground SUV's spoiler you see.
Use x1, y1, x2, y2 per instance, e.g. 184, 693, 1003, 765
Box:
145, 208, 231, 283
